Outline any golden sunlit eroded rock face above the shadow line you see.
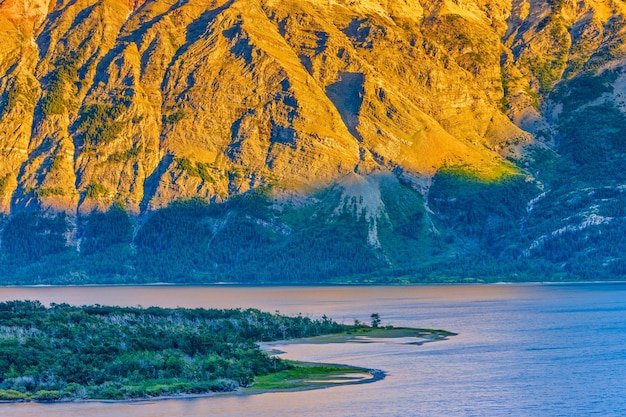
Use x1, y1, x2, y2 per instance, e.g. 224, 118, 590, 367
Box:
0, 0, 626, 213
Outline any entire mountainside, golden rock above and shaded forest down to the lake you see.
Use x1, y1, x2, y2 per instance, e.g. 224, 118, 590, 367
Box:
0, 0, 626, 283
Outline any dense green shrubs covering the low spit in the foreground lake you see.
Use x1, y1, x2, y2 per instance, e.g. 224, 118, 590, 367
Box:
0, 301, 347, 401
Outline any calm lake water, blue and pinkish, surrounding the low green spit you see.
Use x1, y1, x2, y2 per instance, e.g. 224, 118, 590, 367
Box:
0, 284, 626, 417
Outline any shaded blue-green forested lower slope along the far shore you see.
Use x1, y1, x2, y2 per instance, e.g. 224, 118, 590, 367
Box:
0, 156, 626, 284
